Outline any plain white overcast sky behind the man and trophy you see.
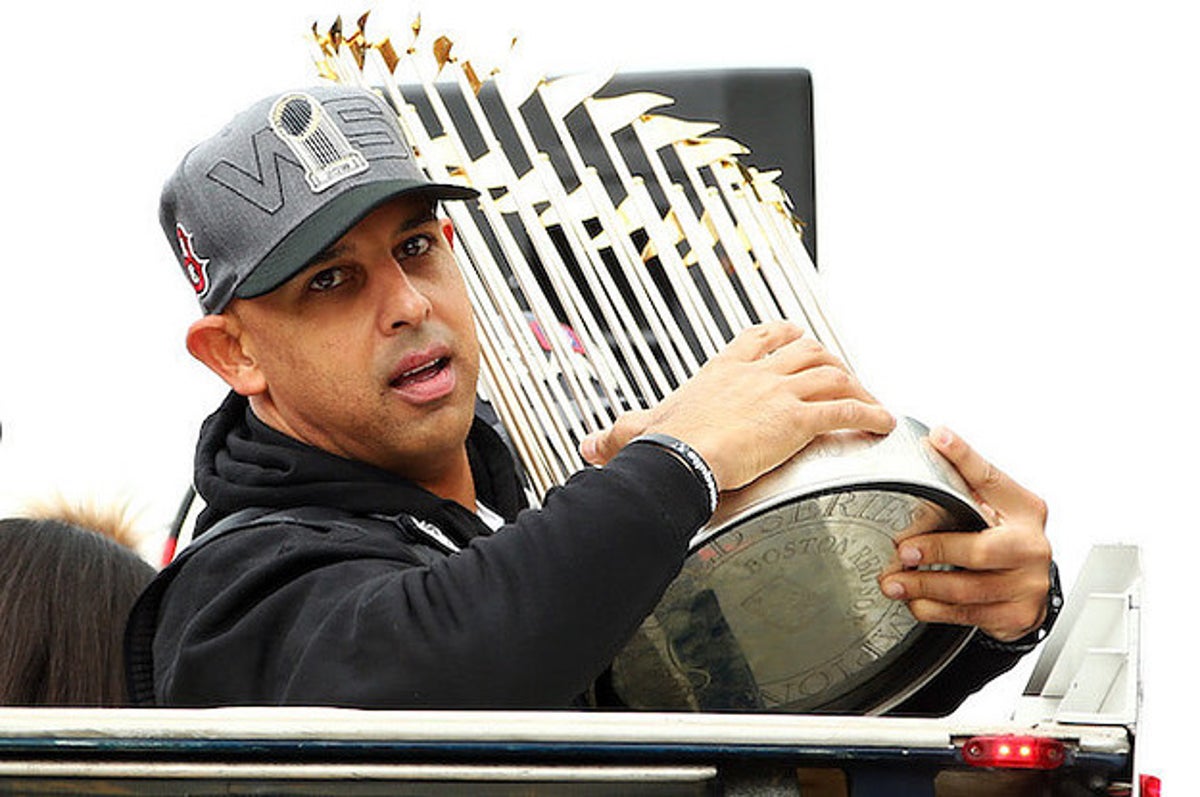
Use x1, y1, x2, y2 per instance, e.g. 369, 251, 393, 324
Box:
0, 0, 1200, 793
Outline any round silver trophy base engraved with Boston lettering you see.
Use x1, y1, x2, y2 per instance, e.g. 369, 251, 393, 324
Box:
612, 418, 985, 714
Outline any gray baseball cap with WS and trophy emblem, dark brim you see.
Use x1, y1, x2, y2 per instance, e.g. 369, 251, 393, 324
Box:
158, 84, 479, 313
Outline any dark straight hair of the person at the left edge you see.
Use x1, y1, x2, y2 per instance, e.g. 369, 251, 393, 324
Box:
0, 517, 155, 706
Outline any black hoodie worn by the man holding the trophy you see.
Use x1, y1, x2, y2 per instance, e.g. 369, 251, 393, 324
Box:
127, 394, 1036, 714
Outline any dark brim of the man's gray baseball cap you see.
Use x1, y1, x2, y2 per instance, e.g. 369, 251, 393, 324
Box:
234, 180, 479, 299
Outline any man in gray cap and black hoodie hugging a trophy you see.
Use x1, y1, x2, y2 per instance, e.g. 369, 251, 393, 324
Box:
128, 86, 1050, 711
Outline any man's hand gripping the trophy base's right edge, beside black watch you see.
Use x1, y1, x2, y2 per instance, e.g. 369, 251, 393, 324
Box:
880, 429, 1051, 642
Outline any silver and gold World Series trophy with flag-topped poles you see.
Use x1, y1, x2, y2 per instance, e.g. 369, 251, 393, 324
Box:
312, 14, 986, 713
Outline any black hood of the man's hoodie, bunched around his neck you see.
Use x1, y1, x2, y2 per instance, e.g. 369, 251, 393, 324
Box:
194, 392, 526, 541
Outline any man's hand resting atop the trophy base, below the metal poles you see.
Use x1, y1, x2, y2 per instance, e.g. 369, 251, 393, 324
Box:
580, 322, 895, 490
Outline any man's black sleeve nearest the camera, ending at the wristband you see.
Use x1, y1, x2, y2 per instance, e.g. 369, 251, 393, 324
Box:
152, 447, 708, 708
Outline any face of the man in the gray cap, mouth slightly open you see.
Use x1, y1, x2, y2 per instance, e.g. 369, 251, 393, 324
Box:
228, 197, 479, 486
